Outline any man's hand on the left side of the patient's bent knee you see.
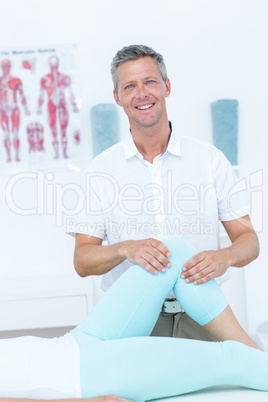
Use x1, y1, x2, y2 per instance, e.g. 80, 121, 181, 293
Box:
124, 238, 171, 274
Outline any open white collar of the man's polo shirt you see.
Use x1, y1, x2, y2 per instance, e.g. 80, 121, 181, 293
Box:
123, 123, 181, 159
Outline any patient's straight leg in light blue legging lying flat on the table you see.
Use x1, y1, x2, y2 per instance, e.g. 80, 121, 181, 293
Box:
80, 337, 268, 401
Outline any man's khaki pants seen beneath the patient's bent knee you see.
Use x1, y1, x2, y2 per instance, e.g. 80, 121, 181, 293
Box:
151, 313, 217, 342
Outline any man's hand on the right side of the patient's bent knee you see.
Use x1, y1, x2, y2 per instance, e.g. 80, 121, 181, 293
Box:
181, 249, 230, 285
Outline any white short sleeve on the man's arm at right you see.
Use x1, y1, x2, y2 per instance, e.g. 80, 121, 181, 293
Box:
213, 148, 250, 221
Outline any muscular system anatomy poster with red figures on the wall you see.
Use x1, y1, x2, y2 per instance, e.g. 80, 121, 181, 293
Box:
0, 45, 81, 173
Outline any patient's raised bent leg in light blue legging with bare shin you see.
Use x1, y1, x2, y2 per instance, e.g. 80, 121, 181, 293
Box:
72, 238, 257, 347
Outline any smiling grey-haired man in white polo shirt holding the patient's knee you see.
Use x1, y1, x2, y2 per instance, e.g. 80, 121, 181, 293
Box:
71, 45, 259, 340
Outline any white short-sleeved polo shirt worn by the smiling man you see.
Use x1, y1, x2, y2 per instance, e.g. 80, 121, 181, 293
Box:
69, 125, 249, 290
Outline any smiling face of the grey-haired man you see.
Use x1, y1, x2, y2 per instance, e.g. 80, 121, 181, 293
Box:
114, 57, 170, 128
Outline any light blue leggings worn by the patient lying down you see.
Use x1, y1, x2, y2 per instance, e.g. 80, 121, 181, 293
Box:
71, 238, 268, 401
